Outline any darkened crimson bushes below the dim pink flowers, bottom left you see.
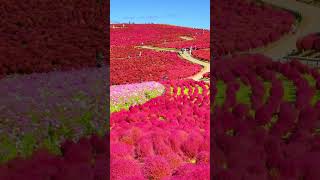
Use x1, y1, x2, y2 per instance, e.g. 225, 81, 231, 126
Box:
0, 136, 108, 180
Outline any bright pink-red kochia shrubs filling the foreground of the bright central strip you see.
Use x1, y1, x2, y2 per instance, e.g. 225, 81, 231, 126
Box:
110, 80, 210, 179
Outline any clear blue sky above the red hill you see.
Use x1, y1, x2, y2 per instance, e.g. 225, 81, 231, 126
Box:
110, 0, 210, 29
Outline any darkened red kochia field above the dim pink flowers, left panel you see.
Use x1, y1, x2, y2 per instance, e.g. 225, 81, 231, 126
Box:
0, 0, 109, 75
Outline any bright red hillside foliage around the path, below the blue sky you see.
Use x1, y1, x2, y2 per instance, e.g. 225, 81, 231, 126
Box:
110, 24, 210, 84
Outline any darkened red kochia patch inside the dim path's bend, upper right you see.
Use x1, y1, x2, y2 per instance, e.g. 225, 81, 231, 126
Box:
210, 0, 295, 56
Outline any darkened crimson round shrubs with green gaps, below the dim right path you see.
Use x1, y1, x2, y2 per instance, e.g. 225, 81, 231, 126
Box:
211, 55, 320, 180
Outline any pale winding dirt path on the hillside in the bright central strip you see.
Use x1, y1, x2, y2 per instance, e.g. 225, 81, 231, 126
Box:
140, 46, 210, 81
